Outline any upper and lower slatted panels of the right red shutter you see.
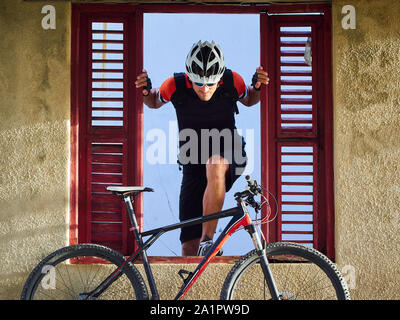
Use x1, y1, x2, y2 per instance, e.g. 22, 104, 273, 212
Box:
277, 24, 318, 247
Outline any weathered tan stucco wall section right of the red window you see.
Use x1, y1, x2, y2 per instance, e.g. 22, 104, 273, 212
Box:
333, 0, 400, 299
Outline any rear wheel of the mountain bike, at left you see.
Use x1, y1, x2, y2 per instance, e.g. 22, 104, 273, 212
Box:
21, 244, 148, 300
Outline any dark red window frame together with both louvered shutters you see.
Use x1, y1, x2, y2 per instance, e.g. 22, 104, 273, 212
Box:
70, 4, 334, 258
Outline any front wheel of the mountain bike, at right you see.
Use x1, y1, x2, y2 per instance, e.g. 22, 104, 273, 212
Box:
220, 242, 350, 300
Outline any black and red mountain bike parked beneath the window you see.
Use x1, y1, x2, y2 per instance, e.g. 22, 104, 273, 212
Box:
21, 176, 350, 300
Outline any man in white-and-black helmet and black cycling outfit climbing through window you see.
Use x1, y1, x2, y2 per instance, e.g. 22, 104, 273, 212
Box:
135, 41, 269, 256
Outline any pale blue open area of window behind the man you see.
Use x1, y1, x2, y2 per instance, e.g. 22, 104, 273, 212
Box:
143, 13, 260, 256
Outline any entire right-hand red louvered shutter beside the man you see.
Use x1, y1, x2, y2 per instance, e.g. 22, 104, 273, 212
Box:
262, 10, 333, 257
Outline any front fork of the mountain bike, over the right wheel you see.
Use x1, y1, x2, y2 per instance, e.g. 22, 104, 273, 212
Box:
245, 224, 280, 300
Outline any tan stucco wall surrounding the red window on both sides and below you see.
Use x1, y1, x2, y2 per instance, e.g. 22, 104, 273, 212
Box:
0, 0, 400, 299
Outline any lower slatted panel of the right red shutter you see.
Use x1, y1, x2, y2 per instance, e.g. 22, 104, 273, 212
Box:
277, 142, 318, 247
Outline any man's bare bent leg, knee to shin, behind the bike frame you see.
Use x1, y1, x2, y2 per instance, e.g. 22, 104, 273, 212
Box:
200, 155, 229, 241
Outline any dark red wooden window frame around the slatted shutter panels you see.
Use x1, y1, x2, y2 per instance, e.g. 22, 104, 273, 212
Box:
69, 4, 334, 263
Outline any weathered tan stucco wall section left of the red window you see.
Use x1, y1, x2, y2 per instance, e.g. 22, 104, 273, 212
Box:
0, 0, 71, 299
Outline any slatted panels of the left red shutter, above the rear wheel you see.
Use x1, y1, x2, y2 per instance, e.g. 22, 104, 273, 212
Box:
87, 20, 128, 252
